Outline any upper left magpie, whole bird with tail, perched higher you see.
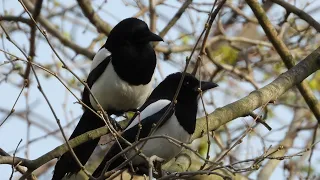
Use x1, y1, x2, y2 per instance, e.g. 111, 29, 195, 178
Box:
52, 18, 163, 180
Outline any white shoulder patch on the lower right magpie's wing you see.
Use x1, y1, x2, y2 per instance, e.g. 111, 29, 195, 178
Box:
124, 99, 171, 131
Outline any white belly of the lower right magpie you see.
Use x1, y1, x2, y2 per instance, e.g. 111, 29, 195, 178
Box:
128, 115, 191, 165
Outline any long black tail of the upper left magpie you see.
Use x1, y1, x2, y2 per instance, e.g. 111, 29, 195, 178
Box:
52, 110, 104, 180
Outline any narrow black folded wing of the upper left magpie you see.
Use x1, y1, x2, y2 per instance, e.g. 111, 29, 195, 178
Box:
82, 56, 111, 107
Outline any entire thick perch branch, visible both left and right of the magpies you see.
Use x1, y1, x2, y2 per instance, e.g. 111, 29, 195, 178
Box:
0, 48, 320, 174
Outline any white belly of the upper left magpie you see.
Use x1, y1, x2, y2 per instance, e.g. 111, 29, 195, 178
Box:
90, 62, 153, 110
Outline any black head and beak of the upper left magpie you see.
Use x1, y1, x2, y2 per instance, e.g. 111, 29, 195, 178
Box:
105, 18, 163, 53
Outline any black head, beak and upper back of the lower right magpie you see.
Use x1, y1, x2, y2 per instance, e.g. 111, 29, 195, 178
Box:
150, 72, 218, 102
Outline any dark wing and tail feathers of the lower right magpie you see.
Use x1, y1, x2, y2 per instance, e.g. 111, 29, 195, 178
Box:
92, 104, 174, 177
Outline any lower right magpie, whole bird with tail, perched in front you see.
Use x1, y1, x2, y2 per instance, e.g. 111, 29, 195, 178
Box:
93, 73, 218, 177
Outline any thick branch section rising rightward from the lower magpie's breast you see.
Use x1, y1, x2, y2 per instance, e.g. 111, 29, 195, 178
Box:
192, 45, 320, 140
